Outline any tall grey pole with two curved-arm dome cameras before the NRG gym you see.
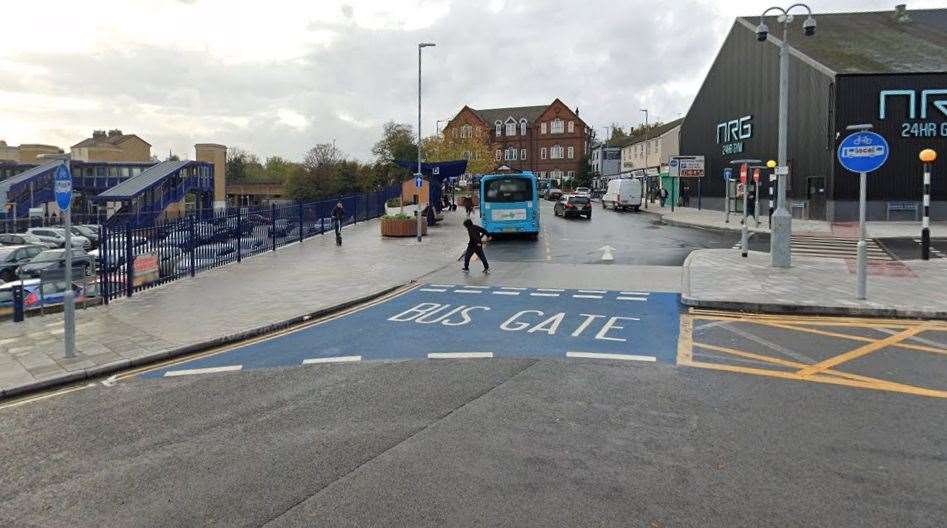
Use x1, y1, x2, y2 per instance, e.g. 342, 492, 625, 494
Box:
756, 4, 815, 268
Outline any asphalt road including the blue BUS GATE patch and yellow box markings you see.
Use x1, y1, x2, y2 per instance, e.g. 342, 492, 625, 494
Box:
0, 210, 947, 528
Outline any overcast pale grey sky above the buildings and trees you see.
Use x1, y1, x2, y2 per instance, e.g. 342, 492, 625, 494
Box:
0, 0, 945, 160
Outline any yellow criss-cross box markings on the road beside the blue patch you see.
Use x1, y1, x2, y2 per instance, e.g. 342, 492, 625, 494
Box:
677, 308, 947, 398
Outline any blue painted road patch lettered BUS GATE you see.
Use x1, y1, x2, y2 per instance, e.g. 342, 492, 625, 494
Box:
141, 284, 681, 378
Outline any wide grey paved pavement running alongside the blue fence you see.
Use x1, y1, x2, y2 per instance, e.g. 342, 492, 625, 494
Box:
0, 213, 464, 396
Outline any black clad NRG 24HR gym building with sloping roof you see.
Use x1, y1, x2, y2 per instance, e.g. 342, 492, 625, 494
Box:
681, 9, 947, 221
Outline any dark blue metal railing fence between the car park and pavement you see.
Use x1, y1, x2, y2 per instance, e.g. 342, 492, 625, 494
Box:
98, 187, 401, 303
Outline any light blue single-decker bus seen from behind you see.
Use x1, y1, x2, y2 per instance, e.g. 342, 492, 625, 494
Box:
480, 171, 539, 240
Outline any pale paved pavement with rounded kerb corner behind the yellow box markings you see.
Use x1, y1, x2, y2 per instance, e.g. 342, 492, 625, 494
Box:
681, 249, 947, 319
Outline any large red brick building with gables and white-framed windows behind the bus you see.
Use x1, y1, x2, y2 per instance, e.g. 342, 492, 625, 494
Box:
444, 99, 588, 181
